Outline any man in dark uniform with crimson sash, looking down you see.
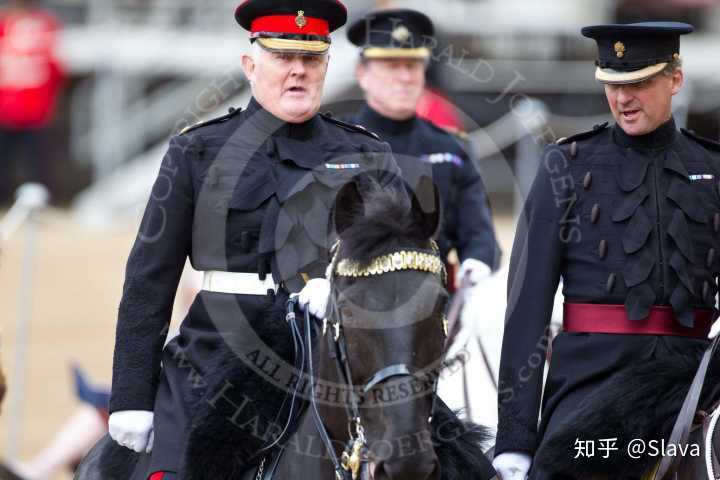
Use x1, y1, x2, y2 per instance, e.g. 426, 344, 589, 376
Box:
494, 22, 720, 480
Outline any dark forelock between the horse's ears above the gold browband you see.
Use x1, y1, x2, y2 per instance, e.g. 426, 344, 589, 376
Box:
339, 181, 429, 262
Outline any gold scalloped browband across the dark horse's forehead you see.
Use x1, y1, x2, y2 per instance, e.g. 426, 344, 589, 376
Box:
335, 250, 446, 282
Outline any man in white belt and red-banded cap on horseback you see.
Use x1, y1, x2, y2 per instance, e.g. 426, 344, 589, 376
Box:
109, 0, 398, 480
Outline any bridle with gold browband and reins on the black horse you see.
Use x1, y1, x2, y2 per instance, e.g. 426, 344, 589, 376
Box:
296, 240, 447, 480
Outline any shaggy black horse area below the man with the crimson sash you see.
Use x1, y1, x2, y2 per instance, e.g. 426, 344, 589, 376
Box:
536, 341, 720, 480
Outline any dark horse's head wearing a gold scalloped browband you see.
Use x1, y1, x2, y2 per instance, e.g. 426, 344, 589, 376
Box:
329, 177, 447, 480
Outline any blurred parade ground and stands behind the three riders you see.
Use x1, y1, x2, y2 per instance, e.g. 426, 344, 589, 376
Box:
0, 0, 720, 478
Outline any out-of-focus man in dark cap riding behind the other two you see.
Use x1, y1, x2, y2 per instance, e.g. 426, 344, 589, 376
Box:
347, 9, 500, 282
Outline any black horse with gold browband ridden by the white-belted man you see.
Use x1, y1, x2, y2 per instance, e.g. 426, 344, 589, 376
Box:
75, 179, 495, 480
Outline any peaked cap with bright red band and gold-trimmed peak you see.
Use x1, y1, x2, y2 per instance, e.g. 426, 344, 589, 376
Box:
235, 0, 347, 54
